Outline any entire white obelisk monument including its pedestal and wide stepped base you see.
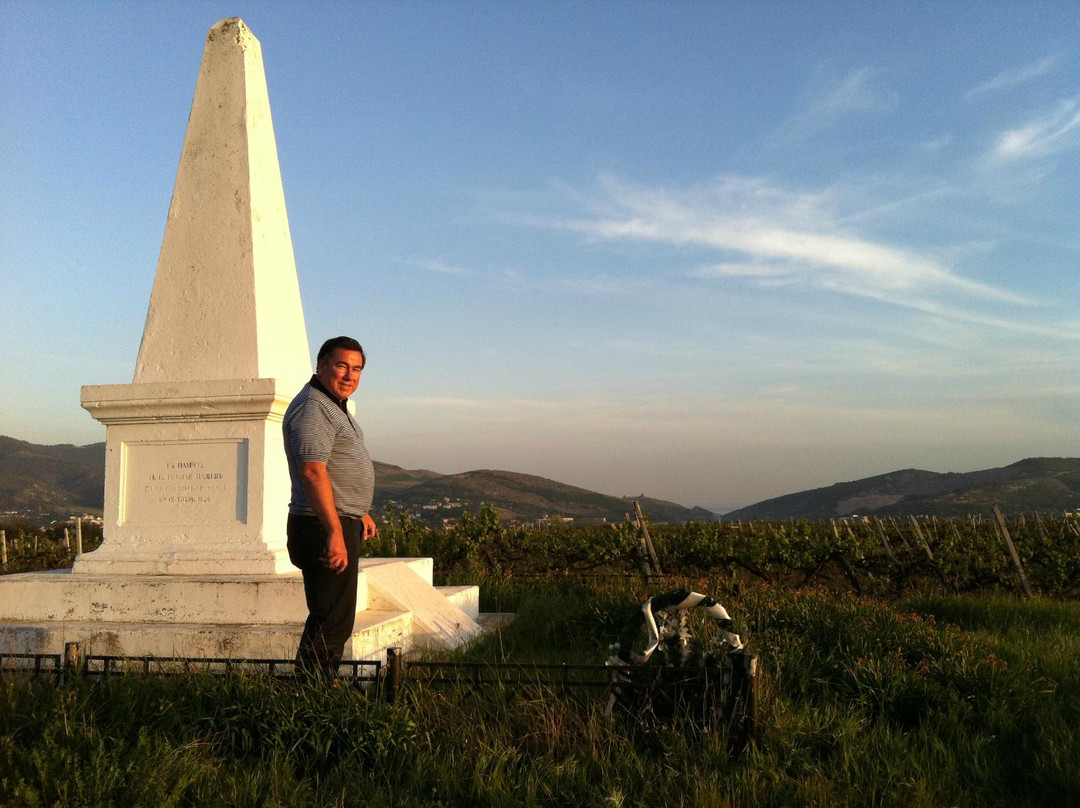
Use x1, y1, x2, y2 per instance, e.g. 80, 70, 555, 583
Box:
0, 18, 481, 659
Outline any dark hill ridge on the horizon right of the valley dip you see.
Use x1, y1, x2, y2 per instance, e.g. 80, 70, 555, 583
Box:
724, 457, 1080, 521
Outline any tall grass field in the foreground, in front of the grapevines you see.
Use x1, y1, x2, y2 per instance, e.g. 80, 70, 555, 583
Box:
0, 576, 1080, 808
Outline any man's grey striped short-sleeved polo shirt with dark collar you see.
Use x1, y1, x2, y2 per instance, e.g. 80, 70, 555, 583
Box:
282, 376, 375, 519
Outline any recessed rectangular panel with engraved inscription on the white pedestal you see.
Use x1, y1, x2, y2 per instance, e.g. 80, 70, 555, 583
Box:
120, 439, 247, 526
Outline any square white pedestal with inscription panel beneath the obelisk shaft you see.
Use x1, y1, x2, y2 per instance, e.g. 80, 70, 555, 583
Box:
75, 379, 299, 575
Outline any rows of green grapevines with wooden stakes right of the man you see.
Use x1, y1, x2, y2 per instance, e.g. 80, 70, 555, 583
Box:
365, 506, 1080, 597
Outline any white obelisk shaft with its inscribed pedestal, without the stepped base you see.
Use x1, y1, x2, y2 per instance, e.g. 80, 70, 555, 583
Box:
75, 18, 311, 575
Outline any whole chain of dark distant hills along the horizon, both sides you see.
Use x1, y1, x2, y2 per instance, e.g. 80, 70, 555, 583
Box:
0, 435, 1080, 524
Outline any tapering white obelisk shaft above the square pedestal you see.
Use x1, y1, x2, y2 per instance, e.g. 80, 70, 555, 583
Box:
134, 17, 311, 384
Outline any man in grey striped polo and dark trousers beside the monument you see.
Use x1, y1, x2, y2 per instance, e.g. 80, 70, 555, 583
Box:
282, 337, 376, 676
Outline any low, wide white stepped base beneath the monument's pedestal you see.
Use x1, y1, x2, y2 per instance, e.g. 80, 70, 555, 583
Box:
0, 558, 482, 659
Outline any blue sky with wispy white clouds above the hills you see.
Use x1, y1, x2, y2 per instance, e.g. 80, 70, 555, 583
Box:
0, 0, 1080, 509
